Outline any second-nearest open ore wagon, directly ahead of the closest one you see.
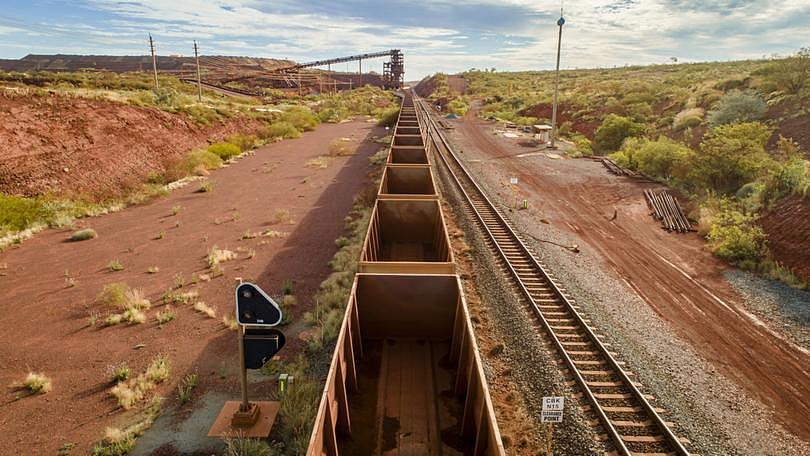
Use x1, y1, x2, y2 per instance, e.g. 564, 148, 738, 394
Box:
359, 199, 455, 274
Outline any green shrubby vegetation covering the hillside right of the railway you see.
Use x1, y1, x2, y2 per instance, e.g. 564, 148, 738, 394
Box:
448, 48, 810, 283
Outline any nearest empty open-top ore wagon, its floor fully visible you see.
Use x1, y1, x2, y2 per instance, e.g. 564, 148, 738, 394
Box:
307, 274, 504, 456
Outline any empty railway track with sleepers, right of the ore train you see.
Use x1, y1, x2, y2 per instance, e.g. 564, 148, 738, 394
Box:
416, 96, 689, 456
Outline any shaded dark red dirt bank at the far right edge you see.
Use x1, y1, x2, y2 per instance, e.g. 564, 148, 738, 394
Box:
760, 196, 810, 282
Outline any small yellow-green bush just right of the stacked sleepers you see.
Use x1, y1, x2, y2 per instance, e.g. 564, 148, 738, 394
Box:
707, 204, 767, 269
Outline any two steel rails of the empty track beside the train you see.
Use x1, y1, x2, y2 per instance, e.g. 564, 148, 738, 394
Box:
414, 97, 689, 455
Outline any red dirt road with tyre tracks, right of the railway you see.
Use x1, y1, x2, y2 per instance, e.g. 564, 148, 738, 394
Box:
454, 109, 810, 440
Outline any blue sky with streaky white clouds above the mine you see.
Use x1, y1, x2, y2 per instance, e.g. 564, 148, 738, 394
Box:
0, 0, 810, 80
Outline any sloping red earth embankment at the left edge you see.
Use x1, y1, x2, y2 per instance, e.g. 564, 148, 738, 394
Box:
0, 91, 261, 199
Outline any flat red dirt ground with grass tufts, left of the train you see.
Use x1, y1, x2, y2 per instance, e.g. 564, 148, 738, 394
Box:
0, 120, 383, 454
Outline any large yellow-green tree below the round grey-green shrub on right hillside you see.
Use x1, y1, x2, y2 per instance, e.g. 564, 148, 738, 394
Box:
690, 122, 775, 195
